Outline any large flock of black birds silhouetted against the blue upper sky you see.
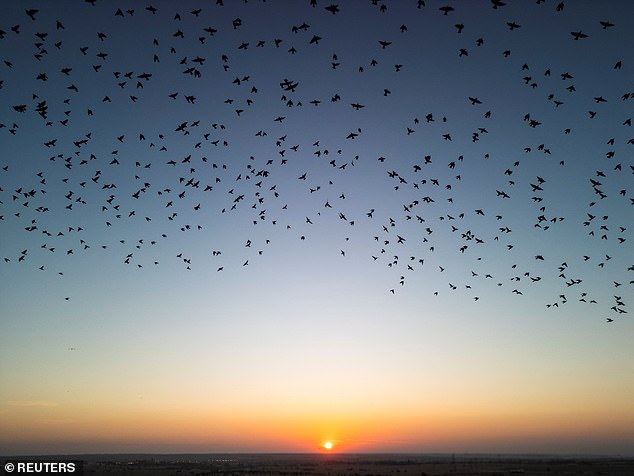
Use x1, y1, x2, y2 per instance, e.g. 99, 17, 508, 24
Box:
0, 0, 634, 322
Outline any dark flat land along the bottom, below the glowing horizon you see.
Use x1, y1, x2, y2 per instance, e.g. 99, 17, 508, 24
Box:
16, 454, 634, 476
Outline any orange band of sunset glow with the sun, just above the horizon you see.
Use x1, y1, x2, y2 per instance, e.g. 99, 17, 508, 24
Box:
0, 400, 634, 454
